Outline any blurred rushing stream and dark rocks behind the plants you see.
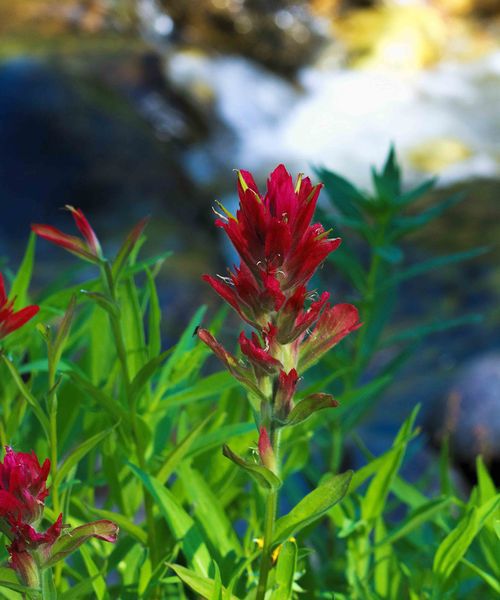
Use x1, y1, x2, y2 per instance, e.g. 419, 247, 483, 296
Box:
0, 0, 500, 477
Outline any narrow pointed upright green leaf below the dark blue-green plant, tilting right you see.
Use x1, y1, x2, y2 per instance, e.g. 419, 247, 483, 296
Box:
361, 405, 420, 521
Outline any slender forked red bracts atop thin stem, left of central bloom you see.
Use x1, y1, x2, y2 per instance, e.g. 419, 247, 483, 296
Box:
31, 205, 102, 263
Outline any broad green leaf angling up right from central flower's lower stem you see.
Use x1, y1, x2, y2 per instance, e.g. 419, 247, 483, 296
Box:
273, 471, 353, 544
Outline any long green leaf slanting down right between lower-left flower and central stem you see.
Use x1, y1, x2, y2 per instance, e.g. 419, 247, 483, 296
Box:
128, 463, 211, 577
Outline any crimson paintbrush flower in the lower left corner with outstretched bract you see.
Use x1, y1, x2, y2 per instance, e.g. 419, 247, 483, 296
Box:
0, 447, 118, 587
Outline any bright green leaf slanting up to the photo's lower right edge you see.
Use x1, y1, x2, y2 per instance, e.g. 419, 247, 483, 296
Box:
432, 494, 500, 580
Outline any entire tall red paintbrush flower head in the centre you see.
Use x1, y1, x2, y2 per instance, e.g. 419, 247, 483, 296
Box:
198, 165, 360, 470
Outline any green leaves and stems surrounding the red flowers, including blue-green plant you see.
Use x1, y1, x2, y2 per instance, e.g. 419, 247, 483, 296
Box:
0, 151, 500, 600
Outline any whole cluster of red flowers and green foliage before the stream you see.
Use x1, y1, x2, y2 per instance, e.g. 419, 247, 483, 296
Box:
0, 152, 500, 600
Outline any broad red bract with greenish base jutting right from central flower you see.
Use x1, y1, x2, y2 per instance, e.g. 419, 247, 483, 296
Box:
299, 304, 362, 372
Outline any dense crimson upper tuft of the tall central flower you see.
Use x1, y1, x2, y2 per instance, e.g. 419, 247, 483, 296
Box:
205, 165, 340, 314
